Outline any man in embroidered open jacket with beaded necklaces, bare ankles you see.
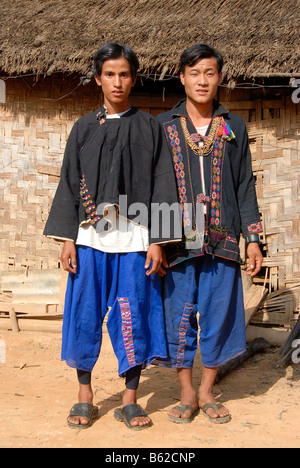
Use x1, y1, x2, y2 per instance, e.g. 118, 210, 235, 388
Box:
158, 44, 262, 423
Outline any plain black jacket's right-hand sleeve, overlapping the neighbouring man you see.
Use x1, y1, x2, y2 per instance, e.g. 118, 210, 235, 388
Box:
150, 119, 182, 244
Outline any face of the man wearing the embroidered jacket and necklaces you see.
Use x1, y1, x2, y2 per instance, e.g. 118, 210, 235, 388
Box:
180, 57, 222, 105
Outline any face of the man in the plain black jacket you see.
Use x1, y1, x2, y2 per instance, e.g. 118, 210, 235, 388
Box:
95, 57, 136, 112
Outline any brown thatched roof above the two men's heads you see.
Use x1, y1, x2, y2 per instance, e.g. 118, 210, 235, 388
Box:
0, 0, 300, 79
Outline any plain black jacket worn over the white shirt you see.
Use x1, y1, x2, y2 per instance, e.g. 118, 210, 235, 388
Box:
44, 107, 181, 243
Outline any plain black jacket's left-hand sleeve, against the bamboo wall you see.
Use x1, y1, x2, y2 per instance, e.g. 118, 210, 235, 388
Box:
44, 122, 81, 241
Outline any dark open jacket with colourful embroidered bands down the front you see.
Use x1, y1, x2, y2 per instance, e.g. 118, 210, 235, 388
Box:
157, 100, 262, 266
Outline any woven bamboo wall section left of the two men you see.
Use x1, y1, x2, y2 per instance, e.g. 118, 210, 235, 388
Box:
0, 79, 97, 271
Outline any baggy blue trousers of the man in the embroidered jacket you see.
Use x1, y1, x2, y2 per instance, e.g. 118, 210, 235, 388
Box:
162, 255, 246, 368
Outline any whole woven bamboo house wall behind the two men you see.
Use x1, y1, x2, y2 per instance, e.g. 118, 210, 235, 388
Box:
0, 76, 300, 324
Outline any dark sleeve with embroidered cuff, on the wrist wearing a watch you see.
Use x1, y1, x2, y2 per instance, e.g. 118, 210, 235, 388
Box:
238, 124, 262, 237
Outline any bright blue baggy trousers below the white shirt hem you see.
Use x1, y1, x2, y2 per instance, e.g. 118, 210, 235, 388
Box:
61, 245, 167, 376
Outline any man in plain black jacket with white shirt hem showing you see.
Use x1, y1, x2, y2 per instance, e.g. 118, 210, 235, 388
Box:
44, 43, 177, 430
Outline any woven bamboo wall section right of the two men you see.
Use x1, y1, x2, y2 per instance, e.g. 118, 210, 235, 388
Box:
224, 96, 300, 325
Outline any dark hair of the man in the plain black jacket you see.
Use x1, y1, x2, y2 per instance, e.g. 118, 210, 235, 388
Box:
93, 42, 139, 79
